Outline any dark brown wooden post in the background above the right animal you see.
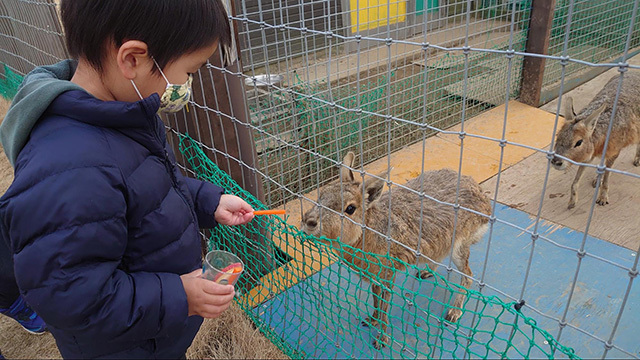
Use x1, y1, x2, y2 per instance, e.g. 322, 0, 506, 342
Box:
520, 0, 556, 107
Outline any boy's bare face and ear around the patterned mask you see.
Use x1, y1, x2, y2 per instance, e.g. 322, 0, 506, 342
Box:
103, 41, 218, 102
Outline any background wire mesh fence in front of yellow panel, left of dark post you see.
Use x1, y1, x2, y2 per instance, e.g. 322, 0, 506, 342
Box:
237, 1, 529, 204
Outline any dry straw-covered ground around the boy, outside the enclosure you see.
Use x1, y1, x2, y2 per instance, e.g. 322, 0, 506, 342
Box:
0, 97, 286, 359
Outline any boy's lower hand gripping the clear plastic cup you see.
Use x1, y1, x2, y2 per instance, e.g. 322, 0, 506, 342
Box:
180, 269, 235, 319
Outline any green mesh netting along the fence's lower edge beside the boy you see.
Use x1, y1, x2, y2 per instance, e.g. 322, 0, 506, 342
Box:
180, 136, 578, 359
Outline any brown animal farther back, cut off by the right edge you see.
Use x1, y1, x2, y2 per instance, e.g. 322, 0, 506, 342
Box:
551, 72, 640, 209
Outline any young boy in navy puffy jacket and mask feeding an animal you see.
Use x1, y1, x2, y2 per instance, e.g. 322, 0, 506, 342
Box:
0, 0, 253, 358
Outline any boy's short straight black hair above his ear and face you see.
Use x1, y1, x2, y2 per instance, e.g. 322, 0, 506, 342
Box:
60, 0, 231, 71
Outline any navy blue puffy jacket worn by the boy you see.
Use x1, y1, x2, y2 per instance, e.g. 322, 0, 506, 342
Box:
0, 90, 222, 358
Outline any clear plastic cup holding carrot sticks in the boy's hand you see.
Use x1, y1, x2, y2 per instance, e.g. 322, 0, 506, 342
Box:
202, 250, 244, 285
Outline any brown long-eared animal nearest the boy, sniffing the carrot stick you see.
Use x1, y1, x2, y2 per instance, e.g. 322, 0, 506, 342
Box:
301, 152, 491, 349
